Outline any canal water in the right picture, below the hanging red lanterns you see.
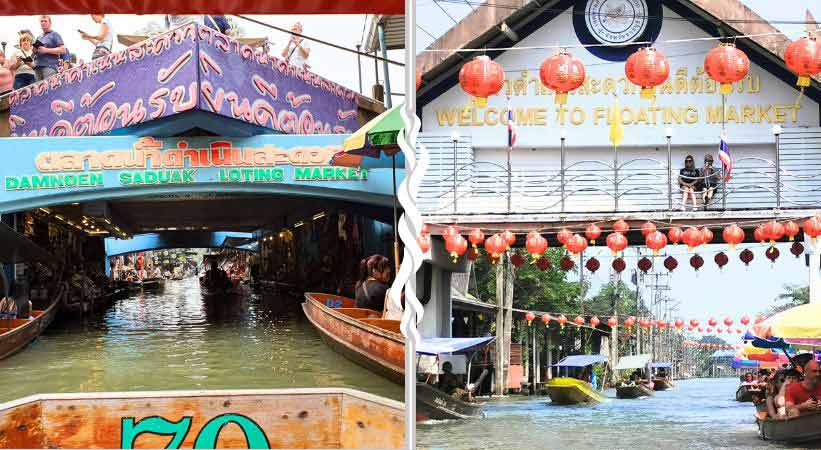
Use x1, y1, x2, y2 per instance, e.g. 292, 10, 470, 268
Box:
417, 378, 808, 450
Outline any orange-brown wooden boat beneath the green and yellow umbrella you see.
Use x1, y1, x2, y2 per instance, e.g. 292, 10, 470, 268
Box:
302, 292, 405, 384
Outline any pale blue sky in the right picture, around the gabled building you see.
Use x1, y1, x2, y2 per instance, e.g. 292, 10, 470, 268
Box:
416, 0, 821, 330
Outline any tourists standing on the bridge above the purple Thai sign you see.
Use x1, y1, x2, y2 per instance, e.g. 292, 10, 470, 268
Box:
0, 14, 311, 95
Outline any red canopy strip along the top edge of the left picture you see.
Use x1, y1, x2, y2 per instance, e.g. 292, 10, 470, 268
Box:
0, 0, 405, 16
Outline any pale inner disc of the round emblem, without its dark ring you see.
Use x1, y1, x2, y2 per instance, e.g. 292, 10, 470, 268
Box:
584, 0, 649, 45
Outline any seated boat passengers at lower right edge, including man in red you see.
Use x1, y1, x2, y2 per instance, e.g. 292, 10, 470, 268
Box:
742, 358, 821, 419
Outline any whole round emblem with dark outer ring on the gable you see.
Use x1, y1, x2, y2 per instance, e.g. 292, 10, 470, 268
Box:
573, 0, 662, 61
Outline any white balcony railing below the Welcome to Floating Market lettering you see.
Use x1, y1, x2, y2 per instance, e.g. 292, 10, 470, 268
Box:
418, 129, 821, 215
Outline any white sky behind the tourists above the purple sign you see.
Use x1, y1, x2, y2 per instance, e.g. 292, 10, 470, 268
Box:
0, 15, 405, 104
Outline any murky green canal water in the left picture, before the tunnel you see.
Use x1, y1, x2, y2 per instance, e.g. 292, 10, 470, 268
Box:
0, 278, 403, 401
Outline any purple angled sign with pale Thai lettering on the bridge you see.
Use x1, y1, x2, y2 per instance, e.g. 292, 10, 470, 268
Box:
9, 24, 358, 136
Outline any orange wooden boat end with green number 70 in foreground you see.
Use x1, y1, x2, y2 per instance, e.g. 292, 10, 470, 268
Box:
0, 389, 405, 449
